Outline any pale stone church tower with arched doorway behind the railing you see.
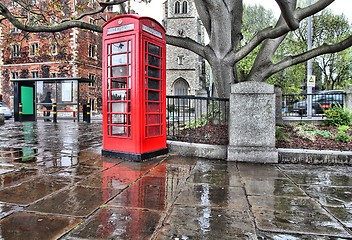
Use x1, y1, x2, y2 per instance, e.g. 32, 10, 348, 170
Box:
163, 0, 206, 96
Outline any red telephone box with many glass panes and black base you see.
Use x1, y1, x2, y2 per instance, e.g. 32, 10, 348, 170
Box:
102, 14, 167, 161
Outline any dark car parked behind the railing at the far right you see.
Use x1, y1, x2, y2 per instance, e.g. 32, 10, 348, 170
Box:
293, 90, 345, 115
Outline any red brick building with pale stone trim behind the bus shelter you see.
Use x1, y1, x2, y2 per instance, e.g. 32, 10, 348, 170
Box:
0, 0, 115, 111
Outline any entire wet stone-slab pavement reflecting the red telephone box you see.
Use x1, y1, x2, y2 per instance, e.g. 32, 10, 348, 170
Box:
0, 121, 352, 240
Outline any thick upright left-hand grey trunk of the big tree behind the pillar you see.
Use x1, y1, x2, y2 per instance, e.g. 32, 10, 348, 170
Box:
195, 0, 243, 98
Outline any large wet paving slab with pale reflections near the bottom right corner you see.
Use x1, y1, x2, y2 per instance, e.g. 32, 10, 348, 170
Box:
248, 196, 348, 237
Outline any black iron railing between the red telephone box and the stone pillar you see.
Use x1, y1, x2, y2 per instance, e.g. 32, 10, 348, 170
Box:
166, 96, 229, 144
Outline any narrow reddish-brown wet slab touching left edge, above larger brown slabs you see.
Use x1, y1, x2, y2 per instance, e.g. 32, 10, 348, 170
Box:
0, 169, 38, 188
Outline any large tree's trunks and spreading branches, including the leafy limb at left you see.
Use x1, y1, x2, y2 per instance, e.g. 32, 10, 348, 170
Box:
0, 0, 352, 97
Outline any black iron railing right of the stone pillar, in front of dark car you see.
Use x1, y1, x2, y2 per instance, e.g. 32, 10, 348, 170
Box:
282, 91, 345, 117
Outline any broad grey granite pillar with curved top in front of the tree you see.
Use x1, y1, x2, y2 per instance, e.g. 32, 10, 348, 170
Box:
227, 82, 278, 163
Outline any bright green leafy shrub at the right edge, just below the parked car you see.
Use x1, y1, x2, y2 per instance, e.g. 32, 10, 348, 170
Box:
324, 106, 352, 127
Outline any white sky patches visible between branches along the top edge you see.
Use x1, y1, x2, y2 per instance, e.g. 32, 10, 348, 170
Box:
131, 0, 352, 22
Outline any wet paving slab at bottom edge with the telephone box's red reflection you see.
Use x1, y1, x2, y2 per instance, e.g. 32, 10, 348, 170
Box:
69, 207, 161, 239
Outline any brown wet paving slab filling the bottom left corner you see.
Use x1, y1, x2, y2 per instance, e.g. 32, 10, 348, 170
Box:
0, 212, 81, 240
